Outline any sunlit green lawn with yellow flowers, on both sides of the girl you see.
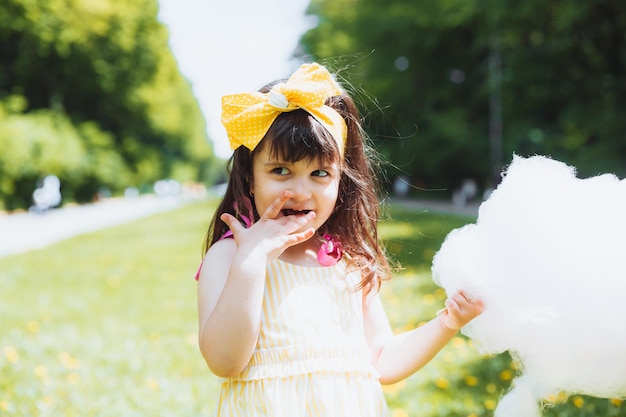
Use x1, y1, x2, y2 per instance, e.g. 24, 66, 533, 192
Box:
0, 202, 626, 417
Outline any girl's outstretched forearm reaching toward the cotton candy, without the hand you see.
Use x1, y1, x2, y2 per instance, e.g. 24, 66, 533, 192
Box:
374, 317, 458, 384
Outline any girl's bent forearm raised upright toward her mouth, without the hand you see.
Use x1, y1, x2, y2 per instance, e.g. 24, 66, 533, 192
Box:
199, 255, 265, 378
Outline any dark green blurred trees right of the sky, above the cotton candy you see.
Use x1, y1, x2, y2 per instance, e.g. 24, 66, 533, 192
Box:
301, 0, 626, 196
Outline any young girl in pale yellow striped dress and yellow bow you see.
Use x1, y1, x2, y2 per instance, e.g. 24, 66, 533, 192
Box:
197, 64, 483, 417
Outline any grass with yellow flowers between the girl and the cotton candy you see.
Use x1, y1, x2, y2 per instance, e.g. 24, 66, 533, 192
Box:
381, 208, 513, 417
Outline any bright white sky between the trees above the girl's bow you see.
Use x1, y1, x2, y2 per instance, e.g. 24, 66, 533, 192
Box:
159, 0, 311, 158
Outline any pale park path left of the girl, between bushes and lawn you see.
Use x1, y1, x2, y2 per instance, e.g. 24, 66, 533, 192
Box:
0, 194, 184, 258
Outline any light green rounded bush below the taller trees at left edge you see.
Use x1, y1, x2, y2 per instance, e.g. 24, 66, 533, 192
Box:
0, 98, 131, 209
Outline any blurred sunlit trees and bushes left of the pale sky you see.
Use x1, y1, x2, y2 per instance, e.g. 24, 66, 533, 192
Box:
0, 0, 216, 206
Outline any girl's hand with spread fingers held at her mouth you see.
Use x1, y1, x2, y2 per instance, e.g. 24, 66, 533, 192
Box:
220, 191, 315, 260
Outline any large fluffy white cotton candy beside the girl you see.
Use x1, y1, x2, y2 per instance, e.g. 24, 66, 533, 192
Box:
432, 156, 626, 417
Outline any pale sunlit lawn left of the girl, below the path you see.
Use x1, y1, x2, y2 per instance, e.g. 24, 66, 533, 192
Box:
0, 200, 217, 417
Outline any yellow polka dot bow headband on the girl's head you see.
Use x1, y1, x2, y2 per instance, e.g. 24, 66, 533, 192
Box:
222, 64, 347, 153
